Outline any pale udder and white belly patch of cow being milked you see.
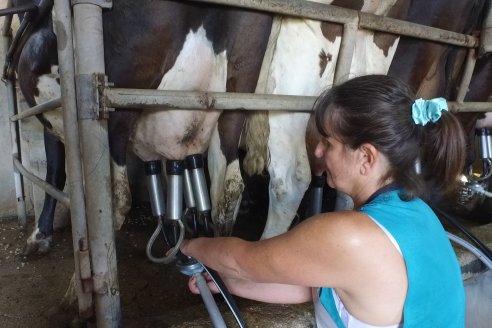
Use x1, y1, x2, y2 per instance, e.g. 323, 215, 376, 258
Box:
130, 28, 227, 161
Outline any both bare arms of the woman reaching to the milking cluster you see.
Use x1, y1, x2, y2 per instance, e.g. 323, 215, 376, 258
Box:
181, 211, 407, 321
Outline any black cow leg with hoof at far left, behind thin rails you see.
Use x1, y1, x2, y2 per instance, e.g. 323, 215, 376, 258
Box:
24, 129, 66, 255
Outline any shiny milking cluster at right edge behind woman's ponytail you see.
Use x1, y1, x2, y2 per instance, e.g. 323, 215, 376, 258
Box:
458, 128, 492, 208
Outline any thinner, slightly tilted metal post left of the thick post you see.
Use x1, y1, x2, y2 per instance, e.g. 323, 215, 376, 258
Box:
54, 0, 93, 318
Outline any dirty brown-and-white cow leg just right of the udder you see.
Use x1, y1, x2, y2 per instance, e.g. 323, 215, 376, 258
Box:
208, 112, 245, 235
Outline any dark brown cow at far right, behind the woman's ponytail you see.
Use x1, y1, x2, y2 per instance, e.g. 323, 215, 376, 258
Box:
388, 0, 492, 217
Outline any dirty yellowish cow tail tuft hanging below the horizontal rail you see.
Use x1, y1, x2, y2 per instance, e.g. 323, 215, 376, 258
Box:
242, 111, 270, 176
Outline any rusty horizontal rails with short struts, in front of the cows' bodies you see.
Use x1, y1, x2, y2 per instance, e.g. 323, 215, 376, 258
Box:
99, 0, 492, 112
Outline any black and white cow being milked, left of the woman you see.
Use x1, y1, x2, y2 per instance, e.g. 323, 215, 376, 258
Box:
12, 0, 272, 252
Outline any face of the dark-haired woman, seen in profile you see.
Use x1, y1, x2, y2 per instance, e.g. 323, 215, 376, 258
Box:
314, 137, 359, 195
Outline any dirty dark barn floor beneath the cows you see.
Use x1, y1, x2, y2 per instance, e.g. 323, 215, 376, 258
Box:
0, 205, 311, 328
